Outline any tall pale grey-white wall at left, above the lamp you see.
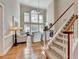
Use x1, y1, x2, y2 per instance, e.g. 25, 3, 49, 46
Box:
4, 0, 19, 34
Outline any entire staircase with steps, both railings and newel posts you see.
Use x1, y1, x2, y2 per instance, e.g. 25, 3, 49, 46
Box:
39, 2, 78, 59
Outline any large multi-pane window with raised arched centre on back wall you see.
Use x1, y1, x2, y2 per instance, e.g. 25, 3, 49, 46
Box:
24, 10, 44, 33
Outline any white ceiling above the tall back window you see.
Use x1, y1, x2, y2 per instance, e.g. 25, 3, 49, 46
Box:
19, 0, 52, 9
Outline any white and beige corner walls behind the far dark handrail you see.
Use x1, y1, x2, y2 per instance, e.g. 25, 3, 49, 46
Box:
46, 0, 74, 32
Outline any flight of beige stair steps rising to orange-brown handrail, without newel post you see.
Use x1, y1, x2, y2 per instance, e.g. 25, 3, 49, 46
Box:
45, 15, 78, 59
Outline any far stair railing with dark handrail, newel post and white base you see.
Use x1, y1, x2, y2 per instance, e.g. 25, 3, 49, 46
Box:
43, 2, 75, 58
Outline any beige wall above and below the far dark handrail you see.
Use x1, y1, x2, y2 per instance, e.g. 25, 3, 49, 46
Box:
54, 0, 74, 31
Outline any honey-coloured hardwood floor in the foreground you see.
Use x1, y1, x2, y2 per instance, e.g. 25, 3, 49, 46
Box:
0, 43, 45, 59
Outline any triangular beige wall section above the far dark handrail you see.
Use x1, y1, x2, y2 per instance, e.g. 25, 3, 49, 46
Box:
54, 0, 73, 18
